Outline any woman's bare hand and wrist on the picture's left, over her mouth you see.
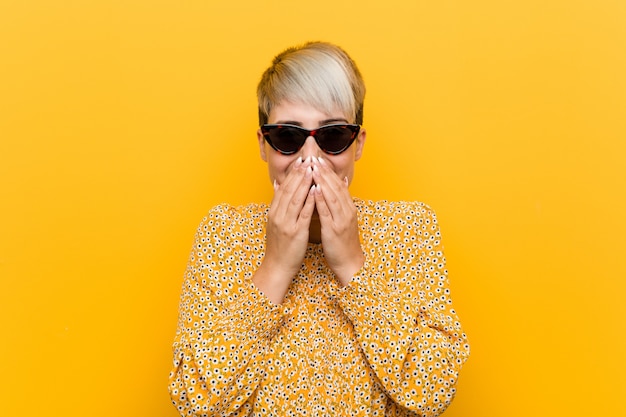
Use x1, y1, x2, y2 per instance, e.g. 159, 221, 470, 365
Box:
252, 158, 315, 304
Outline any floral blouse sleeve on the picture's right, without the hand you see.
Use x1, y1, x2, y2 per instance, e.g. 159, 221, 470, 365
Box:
333, 203, 469, 417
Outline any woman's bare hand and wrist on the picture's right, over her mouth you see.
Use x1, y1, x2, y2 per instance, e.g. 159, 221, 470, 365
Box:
313, 158, 365, 286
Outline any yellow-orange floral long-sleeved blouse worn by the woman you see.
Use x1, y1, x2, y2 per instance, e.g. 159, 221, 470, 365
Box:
169, 199, 469, 416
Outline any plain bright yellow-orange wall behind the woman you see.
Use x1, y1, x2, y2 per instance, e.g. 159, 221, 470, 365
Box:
0, 0, 626, 417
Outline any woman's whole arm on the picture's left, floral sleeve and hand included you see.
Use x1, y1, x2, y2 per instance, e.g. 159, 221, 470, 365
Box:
170, 154, 315, 416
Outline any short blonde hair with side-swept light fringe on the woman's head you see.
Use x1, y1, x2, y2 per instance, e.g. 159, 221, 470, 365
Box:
257, 42, 365, 125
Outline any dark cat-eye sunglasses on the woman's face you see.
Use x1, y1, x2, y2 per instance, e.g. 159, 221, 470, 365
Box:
261, 123, 361, 155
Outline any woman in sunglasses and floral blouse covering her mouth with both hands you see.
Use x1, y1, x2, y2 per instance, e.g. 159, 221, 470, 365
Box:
169, 42, 469, 416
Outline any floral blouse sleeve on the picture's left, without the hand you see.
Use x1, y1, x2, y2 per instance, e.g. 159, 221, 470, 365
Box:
169, 206, 283, 416
